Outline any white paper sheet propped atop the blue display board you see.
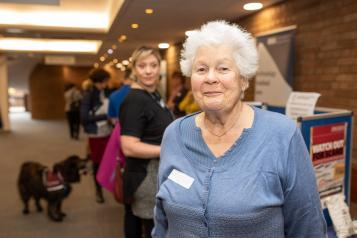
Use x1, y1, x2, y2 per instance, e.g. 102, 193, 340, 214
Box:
285, 92, 320, 120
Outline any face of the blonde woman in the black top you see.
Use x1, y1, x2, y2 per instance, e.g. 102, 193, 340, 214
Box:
134, 55, 160, 88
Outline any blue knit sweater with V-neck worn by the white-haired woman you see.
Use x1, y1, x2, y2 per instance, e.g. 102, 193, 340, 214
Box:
152, 108, 326, 238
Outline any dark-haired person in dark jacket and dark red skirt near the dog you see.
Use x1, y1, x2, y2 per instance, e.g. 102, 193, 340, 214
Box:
80, 68, 111, 203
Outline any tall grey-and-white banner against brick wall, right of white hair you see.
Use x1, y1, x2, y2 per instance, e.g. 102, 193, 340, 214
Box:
254, 26, 296, 106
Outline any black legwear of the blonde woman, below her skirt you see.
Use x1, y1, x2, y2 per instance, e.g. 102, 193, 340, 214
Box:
124, 204, 154, 238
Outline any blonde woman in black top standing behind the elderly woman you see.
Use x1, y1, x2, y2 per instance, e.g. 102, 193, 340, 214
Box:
119, 47, 173, 238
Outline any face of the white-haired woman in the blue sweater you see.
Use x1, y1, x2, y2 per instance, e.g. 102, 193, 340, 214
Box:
191, 45, 244, 111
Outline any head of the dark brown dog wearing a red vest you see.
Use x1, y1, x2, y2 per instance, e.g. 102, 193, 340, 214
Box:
53, 155, 89, 183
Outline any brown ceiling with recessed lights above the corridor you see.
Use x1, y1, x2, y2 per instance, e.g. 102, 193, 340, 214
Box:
0, 0, 282, 65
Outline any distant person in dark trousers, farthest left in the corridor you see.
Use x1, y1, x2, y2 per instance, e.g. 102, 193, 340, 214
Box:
64, 83, 82, 140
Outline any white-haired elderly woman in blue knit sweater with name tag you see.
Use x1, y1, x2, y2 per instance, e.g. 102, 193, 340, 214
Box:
152, 21, 326, 238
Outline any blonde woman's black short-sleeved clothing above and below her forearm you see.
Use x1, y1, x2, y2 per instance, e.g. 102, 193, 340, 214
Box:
119, 89, 173, 203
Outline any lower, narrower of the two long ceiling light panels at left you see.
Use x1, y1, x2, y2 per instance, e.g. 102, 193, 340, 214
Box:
0, 37, 102, 54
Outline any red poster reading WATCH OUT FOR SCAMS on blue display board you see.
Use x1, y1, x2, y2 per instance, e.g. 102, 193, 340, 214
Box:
310, 122, 347, 198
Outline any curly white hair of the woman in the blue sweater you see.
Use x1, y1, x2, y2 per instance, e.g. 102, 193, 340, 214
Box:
180, 21, 258, 80
